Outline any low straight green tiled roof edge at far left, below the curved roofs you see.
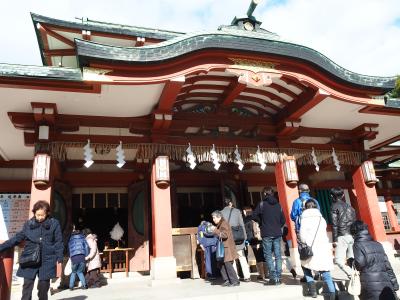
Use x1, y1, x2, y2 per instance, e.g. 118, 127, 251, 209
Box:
0, 64, 82, 81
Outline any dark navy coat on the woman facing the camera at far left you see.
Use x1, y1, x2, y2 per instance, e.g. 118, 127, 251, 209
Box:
0, 217, 64, 280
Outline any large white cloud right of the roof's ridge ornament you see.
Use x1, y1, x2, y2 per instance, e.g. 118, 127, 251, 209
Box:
261, 0, 400, 76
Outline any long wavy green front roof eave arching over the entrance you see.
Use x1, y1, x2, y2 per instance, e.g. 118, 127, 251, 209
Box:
75, 30, 396, 91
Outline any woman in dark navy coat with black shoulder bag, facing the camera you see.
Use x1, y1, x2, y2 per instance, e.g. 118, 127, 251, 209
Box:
0, 201, 64, 300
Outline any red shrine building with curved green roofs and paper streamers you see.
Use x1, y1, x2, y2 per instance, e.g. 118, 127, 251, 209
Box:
0, 2, 400, 279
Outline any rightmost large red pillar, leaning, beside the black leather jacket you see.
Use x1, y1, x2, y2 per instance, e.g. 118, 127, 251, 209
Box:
353, 166, 387, 242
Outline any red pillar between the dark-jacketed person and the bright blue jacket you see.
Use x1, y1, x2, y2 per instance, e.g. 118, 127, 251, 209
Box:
275, 162, 299, 248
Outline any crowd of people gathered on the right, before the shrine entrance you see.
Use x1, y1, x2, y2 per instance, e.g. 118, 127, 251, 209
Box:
198, 184, 399, 300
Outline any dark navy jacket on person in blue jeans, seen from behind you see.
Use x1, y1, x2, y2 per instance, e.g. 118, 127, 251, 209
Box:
253, 196, 286, 238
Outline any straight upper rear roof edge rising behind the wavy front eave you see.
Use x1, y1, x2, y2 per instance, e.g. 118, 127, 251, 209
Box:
31, 12, 184, 40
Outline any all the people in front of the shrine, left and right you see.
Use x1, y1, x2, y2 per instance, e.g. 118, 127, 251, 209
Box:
0, 184, 399, 300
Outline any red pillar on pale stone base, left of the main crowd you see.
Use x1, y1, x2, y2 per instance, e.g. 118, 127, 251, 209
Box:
151, 164, 173, 257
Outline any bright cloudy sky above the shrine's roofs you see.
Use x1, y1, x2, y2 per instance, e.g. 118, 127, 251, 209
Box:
0, 0, 400, 76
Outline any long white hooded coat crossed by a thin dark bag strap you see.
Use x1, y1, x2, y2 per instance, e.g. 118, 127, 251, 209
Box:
300, 208, 333, 271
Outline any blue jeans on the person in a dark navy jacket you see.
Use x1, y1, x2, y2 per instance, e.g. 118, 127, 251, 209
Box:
262, 236, 282, 280
